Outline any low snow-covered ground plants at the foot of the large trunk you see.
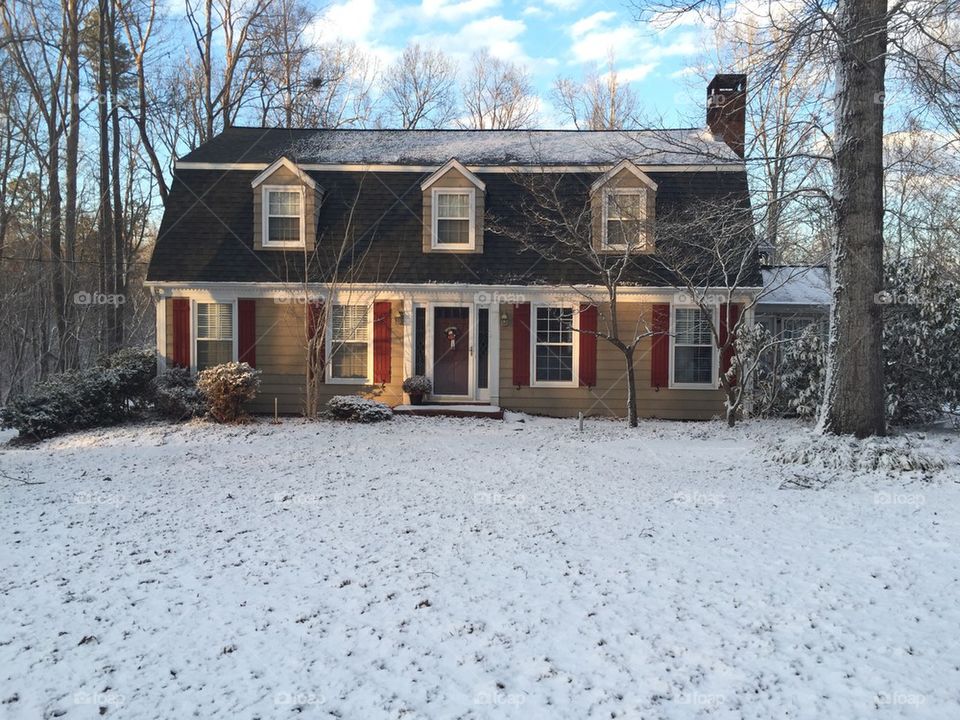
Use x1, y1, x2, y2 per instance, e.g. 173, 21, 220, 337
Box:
770, 435, 946, 473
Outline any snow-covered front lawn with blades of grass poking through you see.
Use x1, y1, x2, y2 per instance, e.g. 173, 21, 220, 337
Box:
0, 416, 960, 720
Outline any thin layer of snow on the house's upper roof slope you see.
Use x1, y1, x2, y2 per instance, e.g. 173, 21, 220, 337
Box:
289, 128, 742, 165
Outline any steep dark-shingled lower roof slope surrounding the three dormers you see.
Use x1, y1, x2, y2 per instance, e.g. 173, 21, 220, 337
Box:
147, 169, 759, 287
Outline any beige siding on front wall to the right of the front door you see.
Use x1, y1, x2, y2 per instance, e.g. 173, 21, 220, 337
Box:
500, 303, 723, 420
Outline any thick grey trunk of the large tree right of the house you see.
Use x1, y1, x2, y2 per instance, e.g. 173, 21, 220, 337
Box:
820, 0, 887, 437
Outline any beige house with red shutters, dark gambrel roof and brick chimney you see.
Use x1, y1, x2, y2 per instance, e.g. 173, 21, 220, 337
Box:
147, 75, 761, 419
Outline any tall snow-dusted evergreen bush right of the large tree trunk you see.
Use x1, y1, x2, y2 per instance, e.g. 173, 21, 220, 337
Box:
878, 263, 960, 424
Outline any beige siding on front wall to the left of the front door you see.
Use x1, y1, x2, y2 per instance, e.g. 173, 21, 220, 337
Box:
250, 299, 403, 414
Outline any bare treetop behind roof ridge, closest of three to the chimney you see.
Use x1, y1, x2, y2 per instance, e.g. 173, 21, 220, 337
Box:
552, 56, 640, 130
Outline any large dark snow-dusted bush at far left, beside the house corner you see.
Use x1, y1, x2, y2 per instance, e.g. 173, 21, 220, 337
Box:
0, 349, 156, 439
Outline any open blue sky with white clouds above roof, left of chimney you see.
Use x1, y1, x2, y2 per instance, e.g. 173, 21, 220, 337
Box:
317, 0, 720, 127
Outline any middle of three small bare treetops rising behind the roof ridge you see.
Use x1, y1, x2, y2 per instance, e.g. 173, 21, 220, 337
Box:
461, 48, 537, 130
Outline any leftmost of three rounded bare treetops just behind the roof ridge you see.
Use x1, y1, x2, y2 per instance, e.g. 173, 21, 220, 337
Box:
382, 43, 457, 130
